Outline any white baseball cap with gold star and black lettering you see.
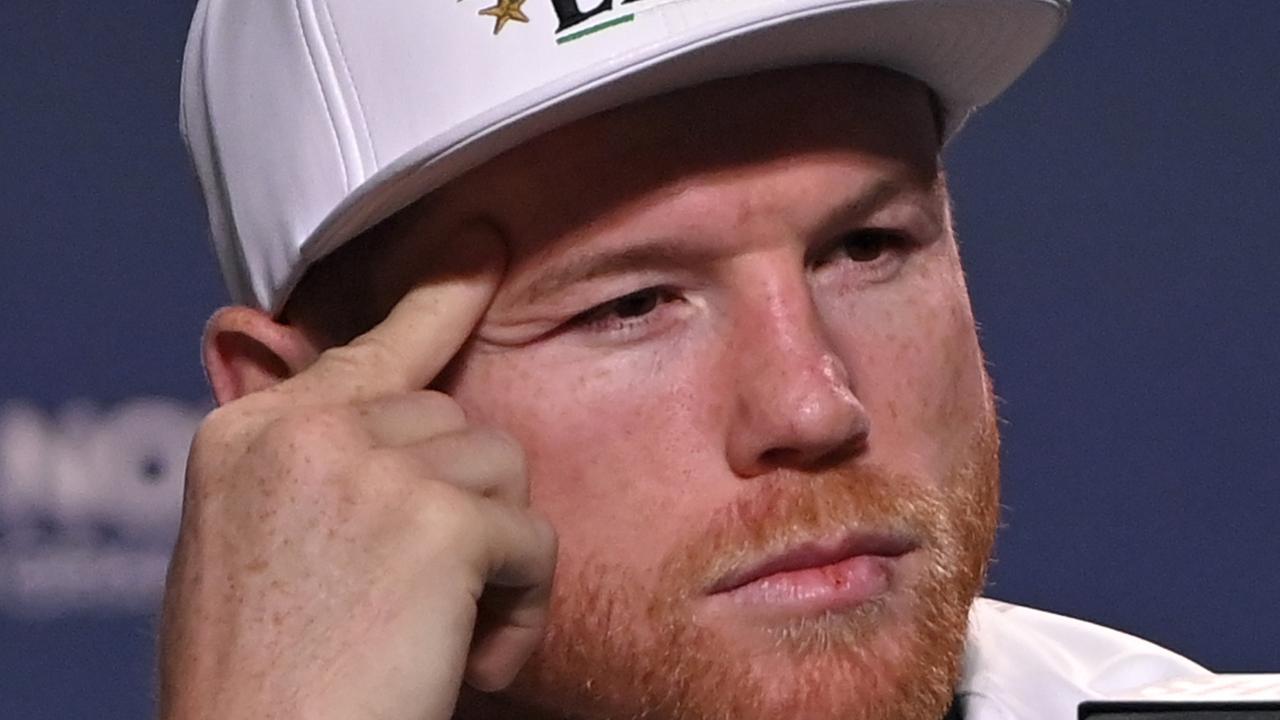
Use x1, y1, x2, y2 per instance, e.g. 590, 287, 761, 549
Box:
182, 0, 1070, 313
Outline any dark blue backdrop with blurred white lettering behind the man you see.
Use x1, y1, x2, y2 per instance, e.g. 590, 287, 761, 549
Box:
0, 0, 1280, 720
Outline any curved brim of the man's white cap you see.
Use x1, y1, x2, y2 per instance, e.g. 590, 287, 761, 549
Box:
271, 0, 1065, 313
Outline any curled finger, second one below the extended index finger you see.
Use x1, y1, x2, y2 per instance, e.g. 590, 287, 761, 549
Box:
407, 428, 529, 507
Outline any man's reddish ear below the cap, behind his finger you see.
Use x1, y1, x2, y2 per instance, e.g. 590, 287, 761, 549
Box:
202, 306, 320, 405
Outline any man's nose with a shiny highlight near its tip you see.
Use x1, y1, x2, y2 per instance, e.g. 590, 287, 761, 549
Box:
727, 269, 870, 478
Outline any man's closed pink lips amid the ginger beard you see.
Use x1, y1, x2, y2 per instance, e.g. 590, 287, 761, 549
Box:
707, 533, 919, 614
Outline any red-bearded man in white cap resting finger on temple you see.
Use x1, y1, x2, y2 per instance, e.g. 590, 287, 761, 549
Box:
161, 0, 1199, 720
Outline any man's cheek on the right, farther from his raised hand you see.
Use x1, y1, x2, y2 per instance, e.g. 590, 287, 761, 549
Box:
820, 256, 988, 477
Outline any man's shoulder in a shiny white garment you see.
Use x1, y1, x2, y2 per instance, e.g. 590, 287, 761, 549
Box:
960, 598, 1208, 720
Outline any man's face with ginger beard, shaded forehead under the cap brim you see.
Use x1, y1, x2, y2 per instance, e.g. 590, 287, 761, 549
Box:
360, 67, 997, 720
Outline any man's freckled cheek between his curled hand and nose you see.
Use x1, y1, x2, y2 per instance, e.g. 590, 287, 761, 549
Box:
451, 343, 732, 573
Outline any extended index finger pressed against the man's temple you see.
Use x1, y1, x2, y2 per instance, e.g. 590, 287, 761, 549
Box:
291, 223, 506, 402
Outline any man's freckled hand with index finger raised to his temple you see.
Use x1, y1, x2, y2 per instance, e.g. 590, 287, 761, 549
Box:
160, 233, 556, 720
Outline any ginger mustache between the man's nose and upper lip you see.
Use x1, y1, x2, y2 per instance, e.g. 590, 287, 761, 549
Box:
660, 465, 947, 600
